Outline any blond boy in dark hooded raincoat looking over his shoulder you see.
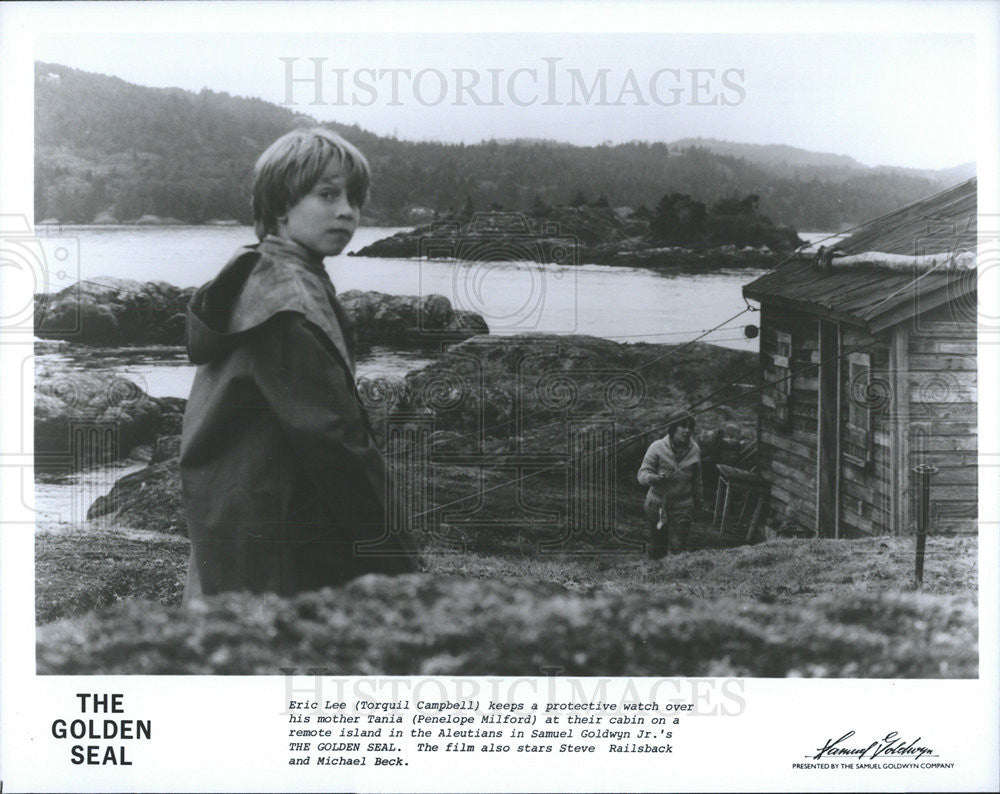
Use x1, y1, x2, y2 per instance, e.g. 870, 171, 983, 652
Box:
181, 128, 416, 600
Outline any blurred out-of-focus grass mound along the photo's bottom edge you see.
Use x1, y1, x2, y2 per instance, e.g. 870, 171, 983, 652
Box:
37, 574, 978, 677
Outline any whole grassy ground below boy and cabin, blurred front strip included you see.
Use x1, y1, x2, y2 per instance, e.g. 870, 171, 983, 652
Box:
36, 530, 978, 678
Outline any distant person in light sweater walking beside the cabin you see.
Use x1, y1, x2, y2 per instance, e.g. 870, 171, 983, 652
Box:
638, 416, 702, 560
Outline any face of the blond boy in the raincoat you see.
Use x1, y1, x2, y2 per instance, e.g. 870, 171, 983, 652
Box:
278, 163, 361, 258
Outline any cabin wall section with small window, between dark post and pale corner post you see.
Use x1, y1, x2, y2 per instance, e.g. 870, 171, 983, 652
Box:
838, 324, 893, 537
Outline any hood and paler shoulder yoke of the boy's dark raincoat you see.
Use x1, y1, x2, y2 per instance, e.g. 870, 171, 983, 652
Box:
187, 235, 353, 370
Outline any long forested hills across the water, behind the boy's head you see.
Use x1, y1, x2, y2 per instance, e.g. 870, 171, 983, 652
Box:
35, 63, 972, 230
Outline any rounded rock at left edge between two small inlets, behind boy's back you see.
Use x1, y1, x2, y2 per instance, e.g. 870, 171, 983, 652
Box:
34, 371, 184, 466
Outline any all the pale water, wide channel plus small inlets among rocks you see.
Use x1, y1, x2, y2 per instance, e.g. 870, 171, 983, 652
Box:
35, 226, 822, 526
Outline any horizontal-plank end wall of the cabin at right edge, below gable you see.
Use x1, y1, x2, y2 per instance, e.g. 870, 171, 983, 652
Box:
899, 302, 979, 532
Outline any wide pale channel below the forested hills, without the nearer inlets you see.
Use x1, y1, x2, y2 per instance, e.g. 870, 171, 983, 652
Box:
50, 226, 760, 358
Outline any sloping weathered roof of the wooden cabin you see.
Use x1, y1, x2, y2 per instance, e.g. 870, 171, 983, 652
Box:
743, 178, 976, 332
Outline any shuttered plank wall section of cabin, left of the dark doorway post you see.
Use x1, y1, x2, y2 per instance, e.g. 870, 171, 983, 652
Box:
757, 304, 819, 528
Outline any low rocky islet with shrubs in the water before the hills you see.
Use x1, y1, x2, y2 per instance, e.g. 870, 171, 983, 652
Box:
349, 193, 804, 271
